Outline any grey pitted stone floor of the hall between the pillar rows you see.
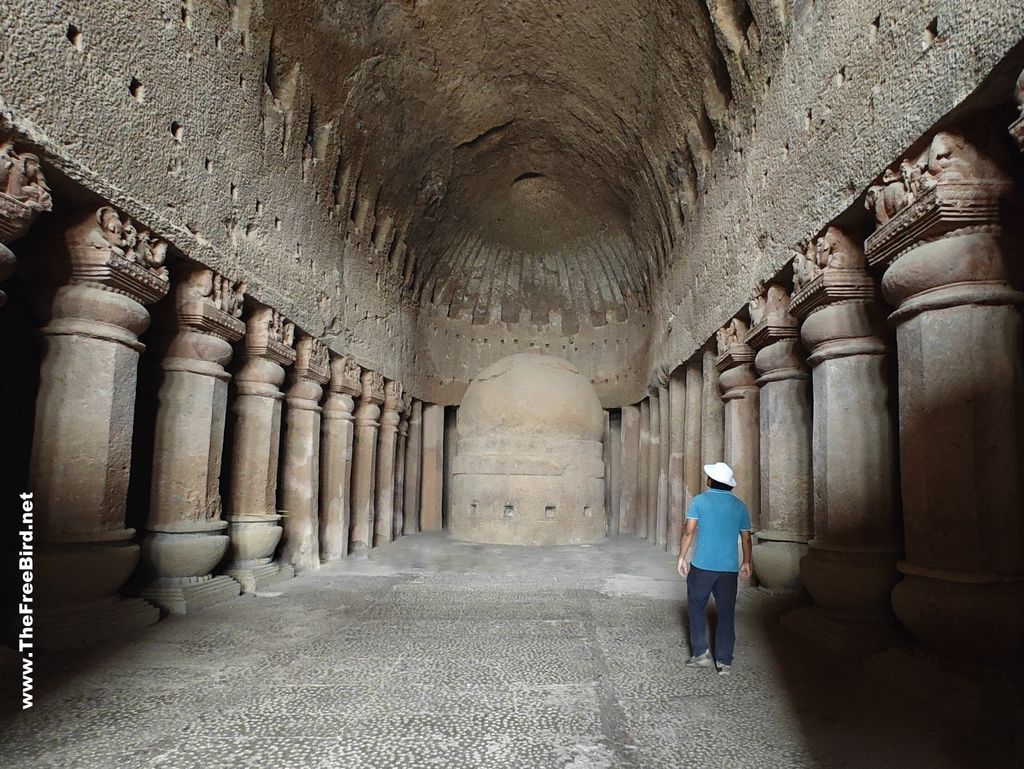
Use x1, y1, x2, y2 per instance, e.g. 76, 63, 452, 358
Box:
0, 536, 1001, 769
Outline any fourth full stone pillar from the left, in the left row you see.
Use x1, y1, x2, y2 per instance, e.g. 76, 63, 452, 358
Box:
281, 335, 331, 573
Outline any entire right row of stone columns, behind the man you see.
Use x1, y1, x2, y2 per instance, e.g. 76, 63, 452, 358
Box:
606, 93, 1024, 678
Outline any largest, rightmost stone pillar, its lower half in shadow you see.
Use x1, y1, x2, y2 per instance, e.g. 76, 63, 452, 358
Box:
865, 132, 1024, 666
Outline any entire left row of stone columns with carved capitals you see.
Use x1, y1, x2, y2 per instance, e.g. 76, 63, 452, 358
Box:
0, 159, 443, 648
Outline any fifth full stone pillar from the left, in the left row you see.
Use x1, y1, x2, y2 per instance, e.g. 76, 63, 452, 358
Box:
319, 356, 362, 562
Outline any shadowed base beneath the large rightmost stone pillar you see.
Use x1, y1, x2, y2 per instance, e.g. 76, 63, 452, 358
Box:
864, 646, 1024, 731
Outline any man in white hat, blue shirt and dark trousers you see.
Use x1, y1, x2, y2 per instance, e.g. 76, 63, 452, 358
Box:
679, 462, 751, 676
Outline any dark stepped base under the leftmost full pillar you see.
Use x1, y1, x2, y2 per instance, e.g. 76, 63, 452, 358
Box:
35, 596, 160, 650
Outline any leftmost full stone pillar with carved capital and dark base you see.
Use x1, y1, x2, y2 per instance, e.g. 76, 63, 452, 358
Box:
29, 207, 170, 648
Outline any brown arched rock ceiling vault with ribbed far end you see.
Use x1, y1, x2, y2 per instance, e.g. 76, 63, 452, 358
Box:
260, 0, 760, 329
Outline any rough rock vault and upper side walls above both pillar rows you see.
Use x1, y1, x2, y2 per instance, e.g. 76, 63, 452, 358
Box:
0, 0, 1024, 405
